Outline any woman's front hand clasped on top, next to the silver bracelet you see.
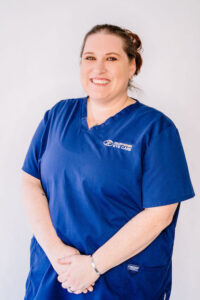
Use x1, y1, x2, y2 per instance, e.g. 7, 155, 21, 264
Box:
57, 254, 100, 294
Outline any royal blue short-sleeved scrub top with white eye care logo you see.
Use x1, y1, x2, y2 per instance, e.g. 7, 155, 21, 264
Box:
22, 96, 195, 300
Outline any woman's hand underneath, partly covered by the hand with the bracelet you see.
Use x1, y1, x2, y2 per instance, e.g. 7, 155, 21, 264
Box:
47, 241, 95, 293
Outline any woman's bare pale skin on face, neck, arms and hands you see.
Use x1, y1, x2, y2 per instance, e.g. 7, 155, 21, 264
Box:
22, 33, 178, 294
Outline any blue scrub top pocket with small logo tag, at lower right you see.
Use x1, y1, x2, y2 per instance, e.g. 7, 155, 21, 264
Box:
124, 261, 171, 300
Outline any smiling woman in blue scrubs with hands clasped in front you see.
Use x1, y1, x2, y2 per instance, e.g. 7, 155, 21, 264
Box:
22, 24, 195, 300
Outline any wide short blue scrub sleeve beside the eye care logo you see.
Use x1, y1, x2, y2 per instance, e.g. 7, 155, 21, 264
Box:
142, 124, 195, 208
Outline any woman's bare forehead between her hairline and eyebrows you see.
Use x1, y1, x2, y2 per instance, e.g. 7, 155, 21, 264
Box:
83, 33, 125, 55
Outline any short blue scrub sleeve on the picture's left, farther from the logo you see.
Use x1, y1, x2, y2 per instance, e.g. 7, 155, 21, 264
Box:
22, 110, 50, 179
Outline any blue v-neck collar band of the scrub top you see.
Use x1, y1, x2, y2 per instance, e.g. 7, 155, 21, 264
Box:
81, 96, 142, 132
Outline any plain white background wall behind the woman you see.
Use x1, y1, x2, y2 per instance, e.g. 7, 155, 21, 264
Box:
0, 0, 200, 300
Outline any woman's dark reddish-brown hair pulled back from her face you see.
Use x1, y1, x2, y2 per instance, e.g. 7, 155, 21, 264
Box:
80, 24, 142, 88
